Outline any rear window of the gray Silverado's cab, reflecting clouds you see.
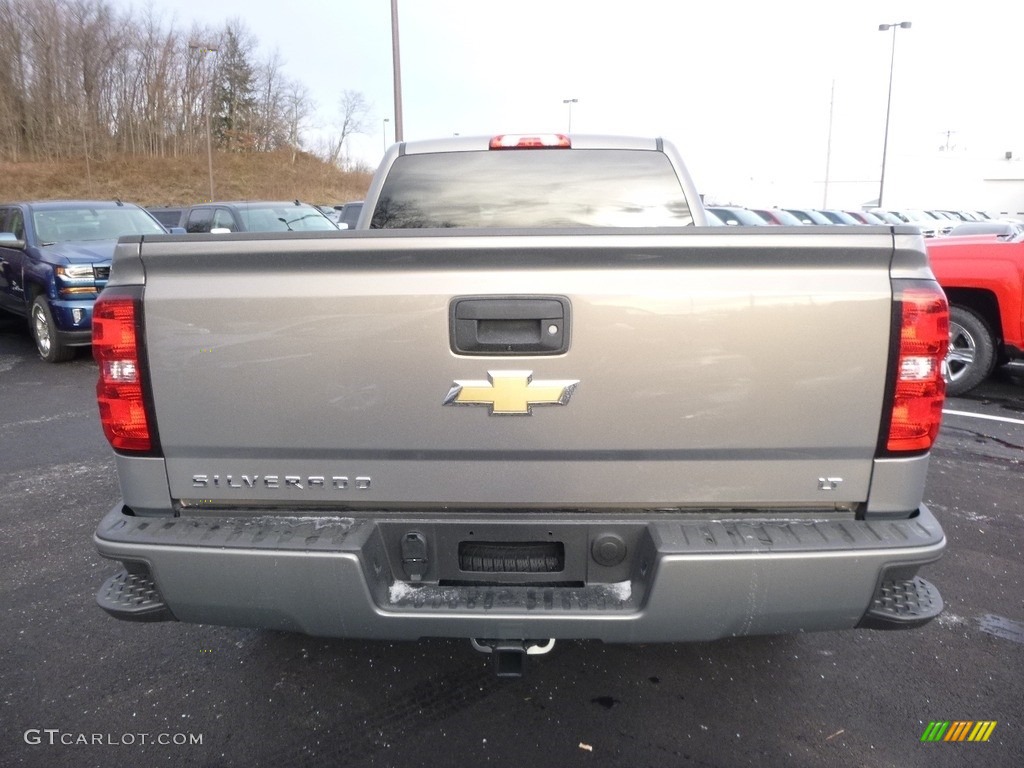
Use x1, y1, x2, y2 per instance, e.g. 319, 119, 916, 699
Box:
370, 150, 693, 229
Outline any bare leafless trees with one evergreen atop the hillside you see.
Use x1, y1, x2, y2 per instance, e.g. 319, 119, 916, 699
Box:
0, 0, 368, 167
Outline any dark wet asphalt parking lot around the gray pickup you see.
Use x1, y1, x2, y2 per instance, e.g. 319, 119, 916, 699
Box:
0, 322, 1024, 768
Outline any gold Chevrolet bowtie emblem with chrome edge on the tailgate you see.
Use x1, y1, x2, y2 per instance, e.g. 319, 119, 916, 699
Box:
444, 371, 580, 416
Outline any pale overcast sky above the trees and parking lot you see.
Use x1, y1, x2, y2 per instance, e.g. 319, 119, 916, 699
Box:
118, 0, 1024, 205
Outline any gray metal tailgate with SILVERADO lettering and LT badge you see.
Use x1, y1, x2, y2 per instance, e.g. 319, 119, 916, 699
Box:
142, 227, 893, 509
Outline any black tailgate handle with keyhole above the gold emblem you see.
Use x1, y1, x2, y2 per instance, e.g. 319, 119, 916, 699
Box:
449, 296, 569, 355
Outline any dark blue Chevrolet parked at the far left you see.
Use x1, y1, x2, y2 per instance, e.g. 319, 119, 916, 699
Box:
0, 200, 167, 362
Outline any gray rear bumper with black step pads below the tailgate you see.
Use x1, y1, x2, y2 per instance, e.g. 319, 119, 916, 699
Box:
94, 506, 945, 642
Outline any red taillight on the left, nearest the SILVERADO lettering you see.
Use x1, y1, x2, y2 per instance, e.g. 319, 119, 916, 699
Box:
92, 292, 156, 453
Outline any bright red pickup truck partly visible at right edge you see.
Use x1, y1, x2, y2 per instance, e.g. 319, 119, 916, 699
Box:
927, 236, 1024, 396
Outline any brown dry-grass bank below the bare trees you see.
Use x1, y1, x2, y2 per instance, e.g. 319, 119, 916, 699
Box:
0, 152, 372, 206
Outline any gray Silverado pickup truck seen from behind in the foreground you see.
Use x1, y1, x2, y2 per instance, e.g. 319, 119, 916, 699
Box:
93, 136, 948, 675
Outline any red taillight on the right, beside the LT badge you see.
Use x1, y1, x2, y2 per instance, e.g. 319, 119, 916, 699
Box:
885, 281, 949, 454
